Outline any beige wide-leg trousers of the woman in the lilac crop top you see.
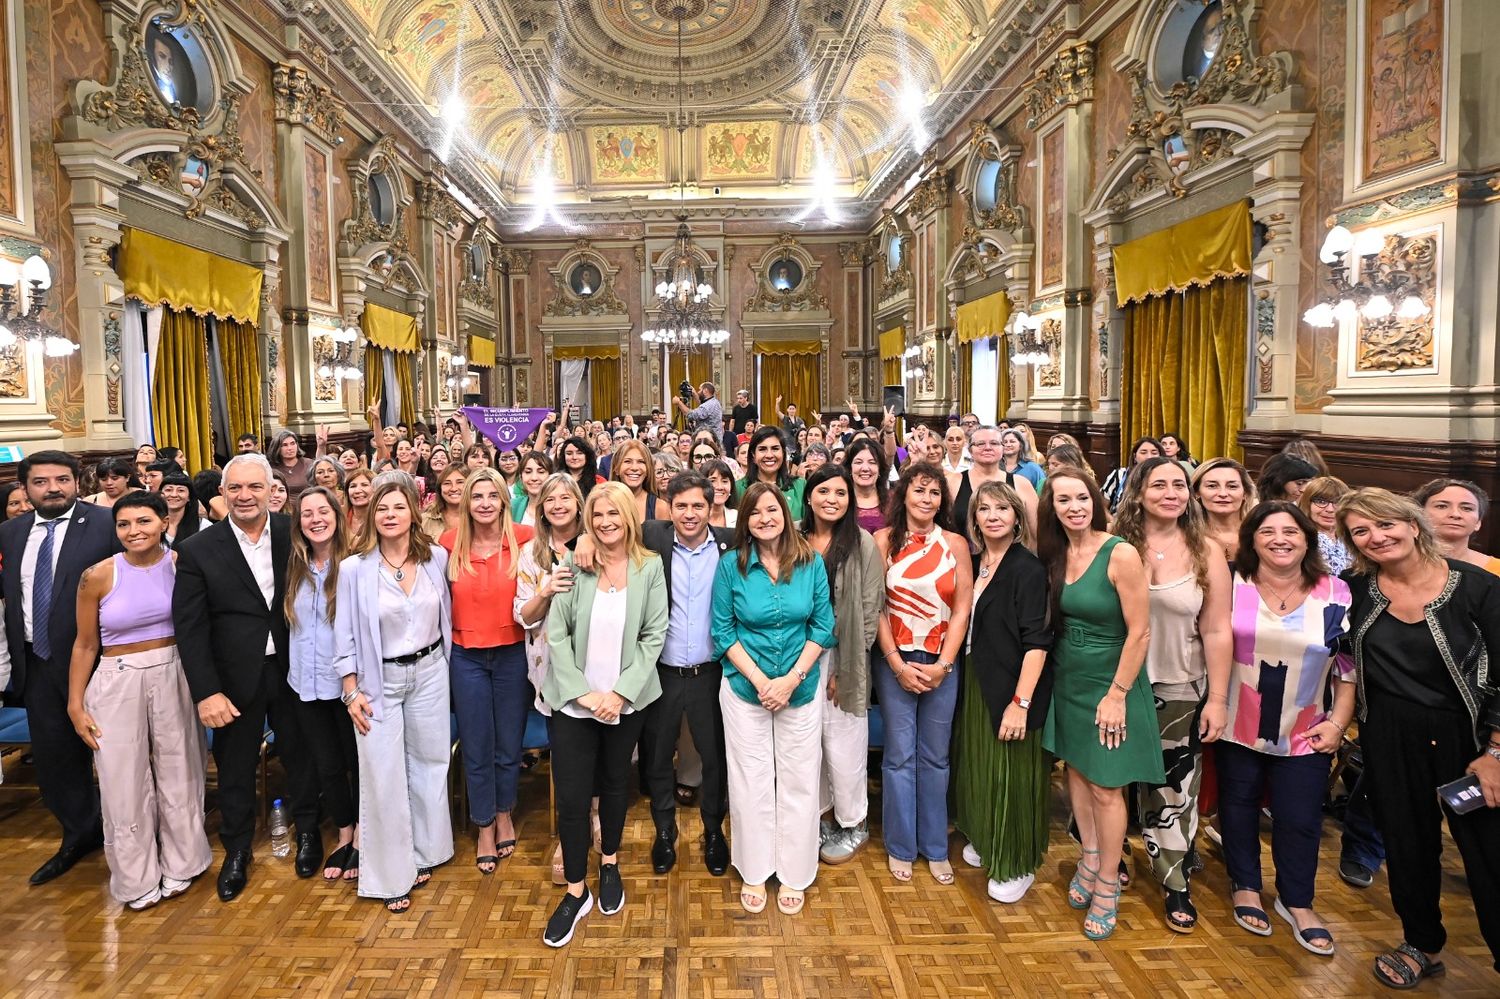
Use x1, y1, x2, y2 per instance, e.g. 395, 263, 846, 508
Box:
84, 645, 213, 902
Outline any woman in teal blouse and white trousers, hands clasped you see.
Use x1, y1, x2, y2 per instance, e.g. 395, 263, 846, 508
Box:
714, 482, 834, 915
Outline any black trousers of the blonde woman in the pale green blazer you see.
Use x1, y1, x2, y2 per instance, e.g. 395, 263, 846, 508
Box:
548, 711, 645, 885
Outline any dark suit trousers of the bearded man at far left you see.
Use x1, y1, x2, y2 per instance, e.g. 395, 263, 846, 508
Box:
21, 645, 104, 848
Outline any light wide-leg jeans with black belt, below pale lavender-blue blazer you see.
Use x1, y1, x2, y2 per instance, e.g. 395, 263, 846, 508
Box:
357, 648, 453, 899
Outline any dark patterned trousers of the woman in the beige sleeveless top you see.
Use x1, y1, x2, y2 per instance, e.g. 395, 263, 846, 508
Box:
1137, 680, 1208, 891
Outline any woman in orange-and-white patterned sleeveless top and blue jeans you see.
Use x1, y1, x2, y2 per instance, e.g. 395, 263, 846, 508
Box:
875, 462, 974, 885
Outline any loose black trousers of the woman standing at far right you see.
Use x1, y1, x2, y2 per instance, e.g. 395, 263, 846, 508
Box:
1359, 692, 1500, 971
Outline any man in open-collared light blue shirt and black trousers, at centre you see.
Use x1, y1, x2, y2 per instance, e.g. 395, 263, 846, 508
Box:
641, 471, 734, 876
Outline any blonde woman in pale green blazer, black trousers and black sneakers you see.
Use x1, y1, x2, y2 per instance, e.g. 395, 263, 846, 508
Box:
542, 482, 668, 947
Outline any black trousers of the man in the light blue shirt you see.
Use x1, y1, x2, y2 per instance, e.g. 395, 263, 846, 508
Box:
641, 666, 729, 830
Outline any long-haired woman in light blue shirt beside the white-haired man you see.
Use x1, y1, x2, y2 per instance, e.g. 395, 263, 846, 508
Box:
282, 486, 360, 884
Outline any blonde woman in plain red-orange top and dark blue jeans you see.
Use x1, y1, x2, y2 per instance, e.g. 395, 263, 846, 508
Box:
438, 467, 531, 875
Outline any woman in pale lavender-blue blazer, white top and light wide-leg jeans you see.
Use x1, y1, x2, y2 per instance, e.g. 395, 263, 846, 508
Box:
335, 473, 450, 912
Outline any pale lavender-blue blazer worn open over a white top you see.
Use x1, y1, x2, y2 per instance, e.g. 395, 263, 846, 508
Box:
333, 545, 453, 719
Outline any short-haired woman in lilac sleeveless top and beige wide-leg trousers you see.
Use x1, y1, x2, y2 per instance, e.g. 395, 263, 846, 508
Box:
68, 492, 212, 911
